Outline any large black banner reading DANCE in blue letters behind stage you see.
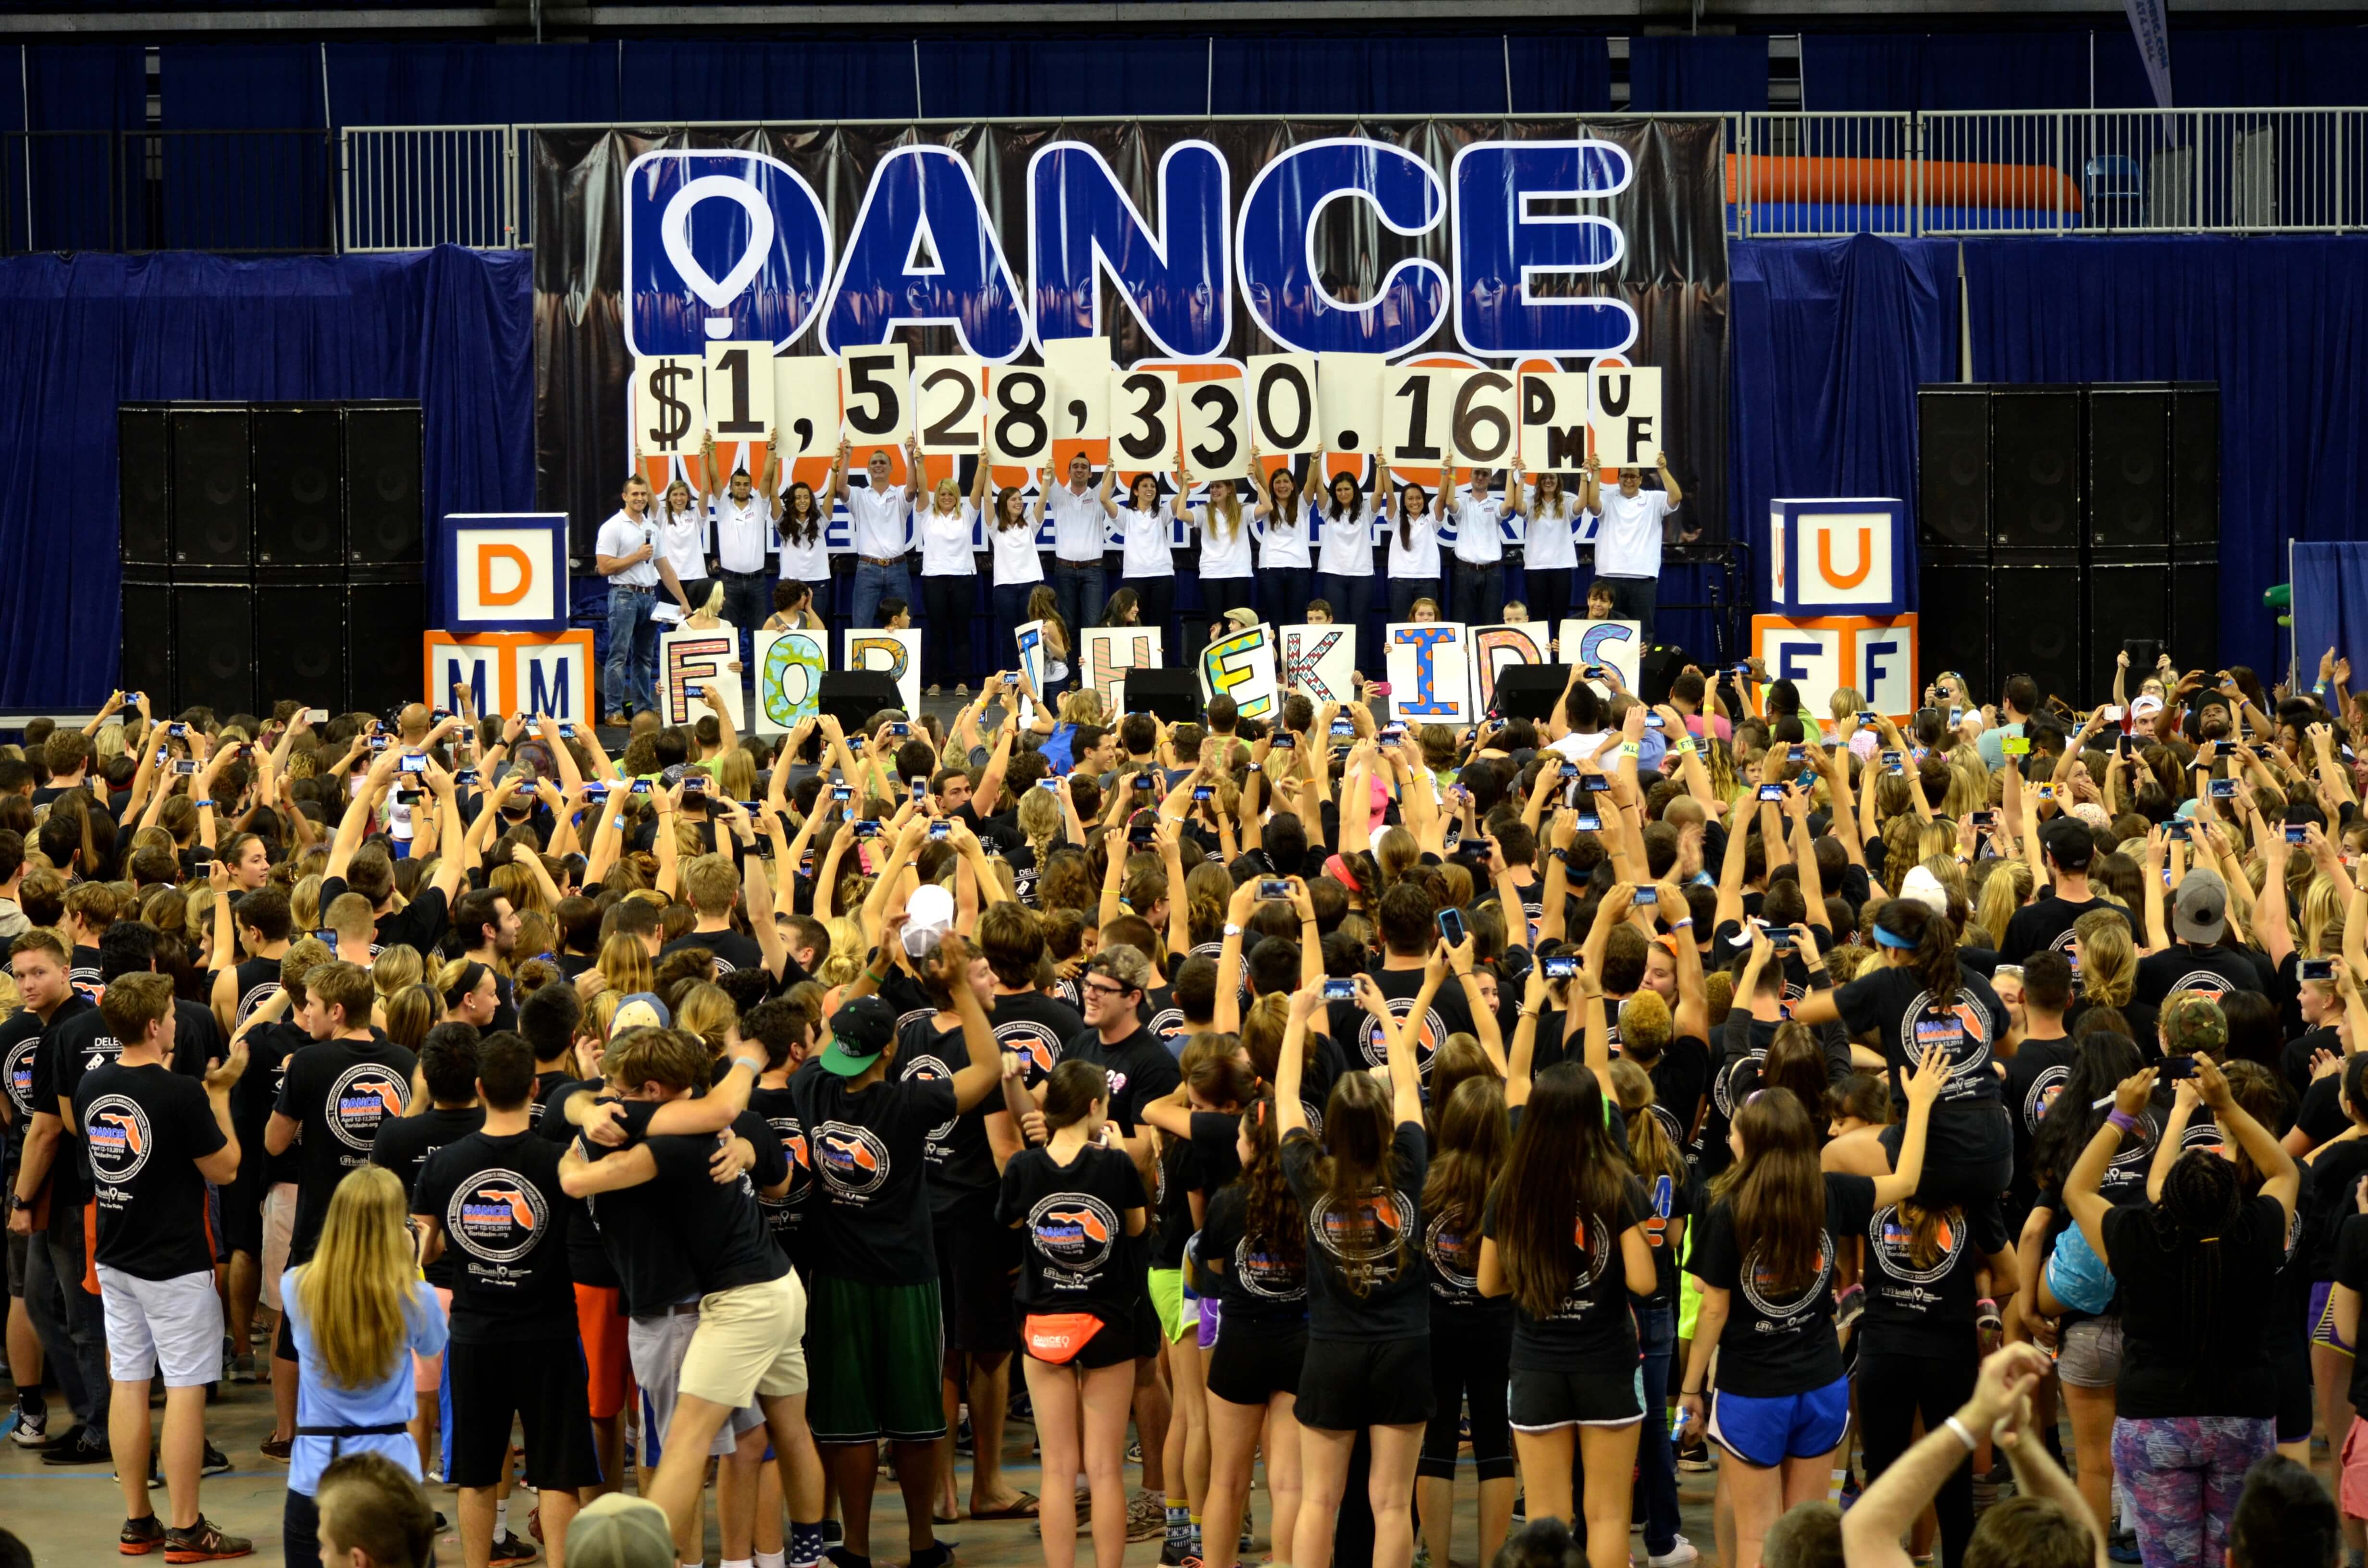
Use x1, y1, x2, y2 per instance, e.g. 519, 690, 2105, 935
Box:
528, 116, 1727, 568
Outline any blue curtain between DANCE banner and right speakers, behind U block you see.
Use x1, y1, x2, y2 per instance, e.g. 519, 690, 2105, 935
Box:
1724, 234, 1958, 625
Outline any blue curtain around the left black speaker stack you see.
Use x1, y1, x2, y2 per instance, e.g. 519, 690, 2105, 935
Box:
0, 249, 535, 708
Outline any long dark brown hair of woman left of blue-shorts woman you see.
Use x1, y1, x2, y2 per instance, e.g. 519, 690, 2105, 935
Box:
1496, 1061, 1634, 1319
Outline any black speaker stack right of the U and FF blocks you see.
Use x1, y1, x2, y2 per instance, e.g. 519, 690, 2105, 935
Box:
1916, 381, 2219, 706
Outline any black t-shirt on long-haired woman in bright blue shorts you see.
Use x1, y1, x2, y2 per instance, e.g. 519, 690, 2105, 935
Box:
1691, 1179, 1875, 1400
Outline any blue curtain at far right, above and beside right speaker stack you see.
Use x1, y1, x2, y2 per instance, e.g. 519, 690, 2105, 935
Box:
1965, 234, 2368, 670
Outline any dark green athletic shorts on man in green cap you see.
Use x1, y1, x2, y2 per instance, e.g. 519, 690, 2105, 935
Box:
805, 1274, 945, 1443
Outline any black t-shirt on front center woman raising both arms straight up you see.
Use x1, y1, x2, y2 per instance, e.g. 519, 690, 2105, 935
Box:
1283, 1123, 1431, 1341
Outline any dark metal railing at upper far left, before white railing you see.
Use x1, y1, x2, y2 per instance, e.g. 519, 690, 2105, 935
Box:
0, 130, 336, 256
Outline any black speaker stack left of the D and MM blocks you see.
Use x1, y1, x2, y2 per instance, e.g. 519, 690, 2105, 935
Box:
116, 403, 426, 715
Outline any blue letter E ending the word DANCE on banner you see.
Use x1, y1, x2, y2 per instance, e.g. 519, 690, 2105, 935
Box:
1449, 142, 1636, 355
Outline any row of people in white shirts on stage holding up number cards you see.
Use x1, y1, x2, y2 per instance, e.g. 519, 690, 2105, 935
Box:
594, 443, 1695, 723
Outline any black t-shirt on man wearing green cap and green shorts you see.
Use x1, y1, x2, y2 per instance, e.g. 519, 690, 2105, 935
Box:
789, 1047, 952, 1284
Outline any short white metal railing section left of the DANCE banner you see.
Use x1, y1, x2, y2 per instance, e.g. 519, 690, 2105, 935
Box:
339, 125, 526, 251
